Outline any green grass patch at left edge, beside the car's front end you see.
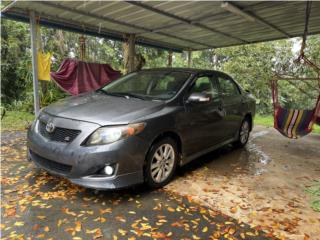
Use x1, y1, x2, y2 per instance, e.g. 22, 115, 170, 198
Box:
1, 111, 34, 130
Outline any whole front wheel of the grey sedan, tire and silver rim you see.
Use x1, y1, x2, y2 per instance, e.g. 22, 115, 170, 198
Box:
145, 138, 178, 188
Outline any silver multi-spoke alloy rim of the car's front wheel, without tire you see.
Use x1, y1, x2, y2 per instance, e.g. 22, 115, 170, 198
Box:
150, 143, 176, 183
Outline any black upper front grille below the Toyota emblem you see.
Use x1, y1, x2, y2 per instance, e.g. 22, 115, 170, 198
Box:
39, 121, 81, 143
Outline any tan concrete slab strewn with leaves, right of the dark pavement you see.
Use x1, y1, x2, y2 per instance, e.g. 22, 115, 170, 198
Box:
166, 126, 320, 239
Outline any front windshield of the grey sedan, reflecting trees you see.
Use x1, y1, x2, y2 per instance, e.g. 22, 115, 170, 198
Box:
100, 71, 190, 100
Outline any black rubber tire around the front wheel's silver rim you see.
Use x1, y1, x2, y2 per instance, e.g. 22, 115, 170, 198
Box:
144, 138, 179, 188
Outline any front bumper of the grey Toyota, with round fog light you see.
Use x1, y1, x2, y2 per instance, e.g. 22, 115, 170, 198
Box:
28, 114, 148, 189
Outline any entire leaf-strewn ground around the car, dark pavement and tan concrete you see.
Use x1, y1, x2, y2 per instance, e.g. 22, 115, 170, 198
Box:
1, 126, 320, 240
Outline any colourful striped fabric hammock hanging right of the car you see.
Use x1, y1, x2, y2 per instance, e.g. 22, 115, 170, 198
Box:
272, 80, 320, 138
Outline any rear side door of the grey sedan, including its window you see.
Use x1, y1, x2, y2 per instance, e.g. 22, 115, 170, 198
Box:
217, 73, 243, 137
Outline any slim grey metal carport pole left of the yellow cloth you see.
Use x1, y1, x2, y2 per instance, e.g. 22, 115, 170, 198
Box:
30, 11, 40, 116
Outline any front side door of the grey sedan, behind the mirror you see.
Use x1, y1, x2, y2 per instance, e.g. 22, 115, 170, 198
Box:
184, 74, 224, 155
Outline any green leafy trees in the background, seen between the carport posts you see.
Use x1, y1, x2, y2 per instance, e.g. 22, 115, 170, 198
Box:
1, 20, 320, 114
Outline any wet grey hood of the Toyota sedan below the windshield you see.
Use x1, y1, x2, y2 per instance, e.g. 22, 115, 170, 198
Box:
44, 92, 165, 125
